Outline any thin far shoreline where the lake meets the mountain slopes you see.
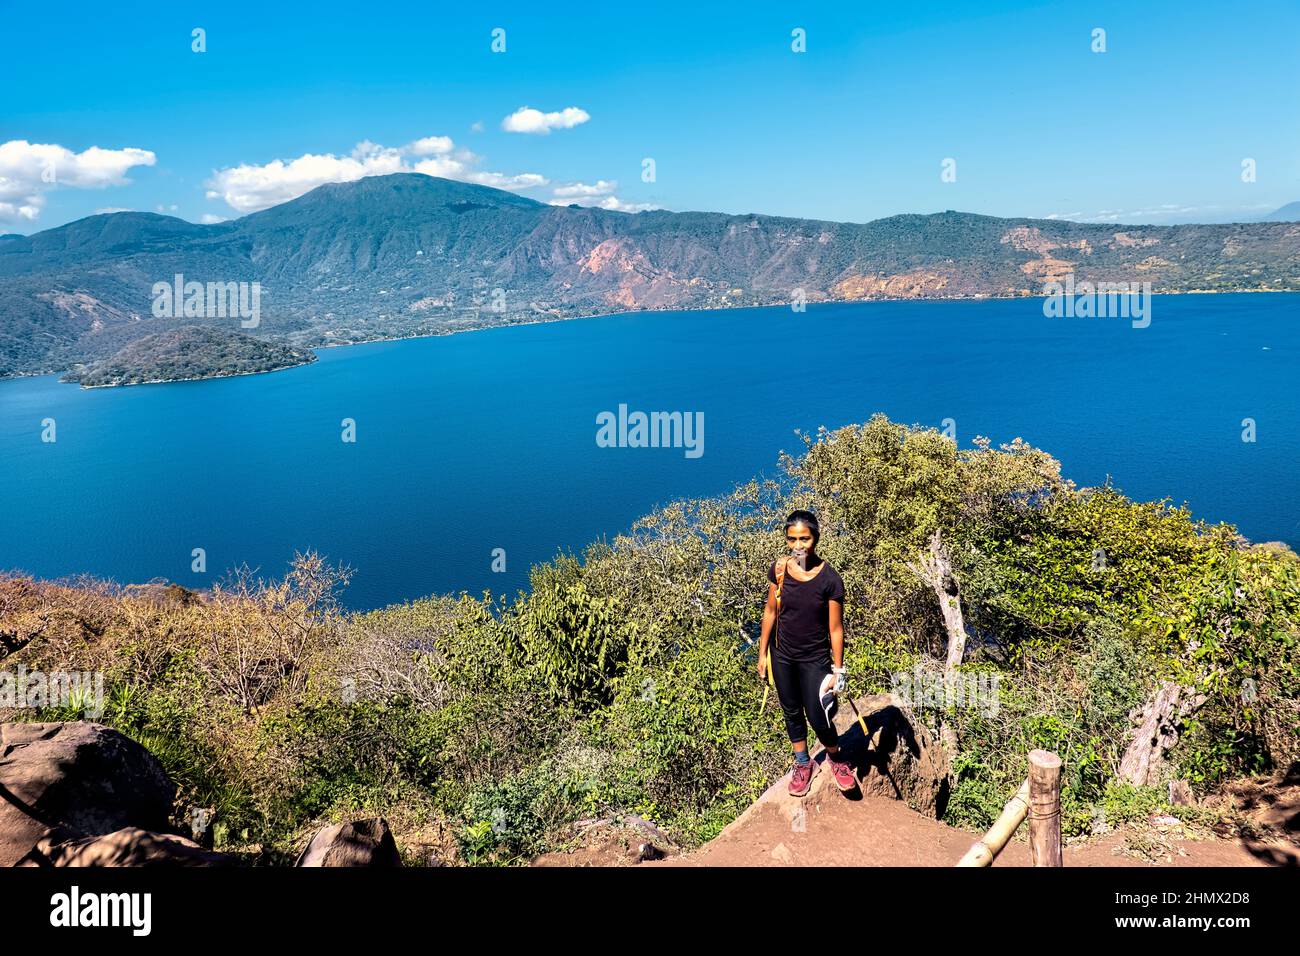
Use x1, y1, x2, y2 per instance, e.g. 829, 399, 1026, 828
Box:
0, 289, 1300, 390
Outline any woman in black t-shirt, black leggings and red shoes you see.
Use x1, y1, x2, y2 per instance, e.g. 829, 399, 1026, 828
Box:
758, 511, 858, 796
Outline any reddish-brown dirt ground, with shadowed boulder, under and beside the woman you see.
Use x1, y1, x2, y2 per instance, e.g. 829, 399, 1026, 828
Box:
533, 695, 1300, 866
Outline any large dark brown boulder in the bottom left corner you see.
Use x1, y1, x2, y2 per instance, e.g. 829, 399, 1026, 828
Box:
0, 721, 176, 866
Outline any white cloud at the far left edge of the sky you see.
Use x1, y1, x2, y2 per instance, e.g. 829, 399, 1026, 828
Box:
0, 139, 157, 221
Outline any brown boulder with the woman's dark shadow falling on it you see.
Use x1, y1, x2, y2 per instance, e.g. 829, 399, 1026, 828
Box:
818, 693, 952, 819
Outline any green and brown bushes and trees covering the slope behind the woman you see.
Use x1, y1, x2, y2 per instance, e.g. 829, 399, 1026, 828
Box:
0, 416, 1300, 864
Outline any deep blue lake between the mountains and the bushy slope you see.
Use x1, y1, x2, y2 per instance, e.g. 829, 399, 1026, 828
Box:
0, 294, 1300, 607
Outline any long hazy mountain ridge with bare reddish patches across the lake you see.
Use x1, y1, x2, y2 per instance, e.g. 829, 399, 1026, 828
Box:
0, 173, 1300, 375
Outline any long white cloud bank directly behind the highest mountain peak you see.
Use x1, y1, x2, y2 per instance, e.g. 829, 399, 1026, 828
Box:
205, 137, 549, 213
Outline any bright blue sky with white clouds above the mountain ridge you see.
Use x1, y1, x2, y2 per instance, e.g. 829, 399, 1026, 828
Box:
0, 0, 1300, 233
